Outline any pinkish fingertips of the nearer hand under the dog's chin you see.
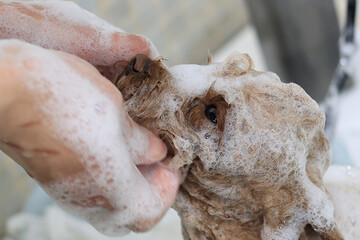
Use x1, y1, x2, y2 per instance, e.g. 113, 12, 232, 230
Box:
117, 118, 181, 232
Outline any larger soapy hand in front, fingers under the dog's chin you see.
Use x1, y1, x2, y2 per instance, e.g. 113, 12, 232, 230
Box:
0, 40, 180, 233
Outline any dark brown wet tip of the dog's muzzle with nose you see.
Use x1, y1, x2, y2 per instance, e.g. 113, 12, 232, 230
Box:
114, 54, 168, 101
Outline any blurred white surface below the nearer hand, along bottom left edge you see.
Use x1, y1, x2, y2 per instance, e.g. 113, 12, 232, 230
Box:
3, 205, 182, 240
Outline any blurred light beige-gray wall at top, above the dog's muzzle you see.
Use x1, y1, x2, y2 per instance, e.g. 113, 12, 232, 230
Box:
74, 0, 248, 66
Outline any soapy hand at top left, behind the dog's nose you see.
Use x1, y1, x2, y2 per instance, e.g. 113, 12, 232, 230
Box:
0, 1, 159, 78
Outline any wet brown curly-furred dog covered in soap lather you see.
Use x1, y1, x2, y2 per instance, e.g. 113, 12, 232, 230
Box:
114, 54, 343, 240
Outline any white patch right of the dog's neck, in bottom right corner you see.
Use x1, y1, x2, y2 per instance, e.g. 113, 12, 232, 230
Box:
324, 166, 360, 240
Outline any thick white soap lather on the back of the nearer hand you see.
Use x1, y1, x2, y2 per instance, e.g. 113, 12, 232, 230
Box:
0, 40, 163, 235
